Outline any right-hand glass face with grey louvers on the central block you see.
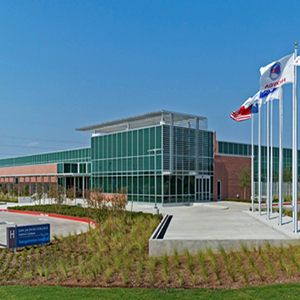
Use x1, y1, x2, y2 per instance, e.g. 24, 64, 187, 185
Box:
163, 125, 213, 204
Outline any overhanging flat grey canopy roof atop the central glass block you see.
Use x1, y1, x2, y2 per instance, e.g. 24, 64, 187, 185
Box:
75, 110, 207, 133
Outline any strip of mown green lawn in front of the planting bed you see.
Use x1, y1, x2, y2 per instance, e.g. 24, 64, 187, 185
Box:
0, 283, 300, 300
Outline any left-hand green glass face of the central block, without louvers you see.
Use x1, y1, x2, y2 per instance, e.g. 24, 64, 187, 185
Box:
91, 126, 162, 202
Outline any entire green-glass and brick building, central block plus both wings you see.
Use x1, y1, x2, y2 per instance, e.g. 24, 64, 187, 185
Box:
0, 110, 299, 205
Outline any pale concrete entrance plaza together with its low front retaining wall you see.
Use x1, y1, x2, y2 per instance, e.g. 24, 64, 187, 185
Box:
127, 201, 300, 256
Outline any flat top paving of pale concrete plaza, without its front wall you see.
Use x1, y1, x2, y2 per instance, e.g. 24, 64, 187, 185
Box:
127, 201, 300, 239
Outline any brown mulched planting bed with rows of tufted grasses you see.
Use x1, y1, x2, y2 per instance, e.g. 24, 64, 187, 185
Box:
0, 205, 300, 289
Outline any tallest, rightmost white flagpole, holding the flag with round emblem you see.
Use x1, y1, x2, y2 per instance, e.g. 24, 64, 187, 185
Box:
293, 43, 298, 233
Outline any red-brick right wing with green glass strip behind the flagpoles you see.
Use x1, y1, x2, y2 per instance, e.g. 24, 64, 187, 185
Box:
214, 138, 300, 200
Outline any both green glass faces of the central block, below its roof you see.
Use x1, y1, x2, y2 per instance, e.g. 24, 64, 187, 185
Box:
91, 125, 213, 204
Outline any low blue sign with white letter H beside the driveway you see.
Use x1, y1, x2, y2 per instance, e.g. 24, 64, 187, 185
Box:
6, 224, 50, 248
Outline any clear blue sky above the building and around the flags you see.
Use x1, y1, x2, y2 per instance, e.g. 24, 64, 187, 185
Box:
0, 0, 300, 158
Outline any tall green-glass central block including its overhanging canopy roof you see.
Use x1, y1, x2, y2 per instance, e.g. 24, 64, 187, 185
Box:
77, 110, 213, 204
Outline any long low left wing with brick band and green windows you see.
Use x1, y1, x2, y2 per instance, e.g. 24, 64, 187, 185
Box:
0, 148, 91, 194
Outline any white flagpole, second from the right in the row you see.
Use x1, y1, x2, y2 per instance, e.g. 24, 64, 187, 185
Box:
278, 86, 283, 225
